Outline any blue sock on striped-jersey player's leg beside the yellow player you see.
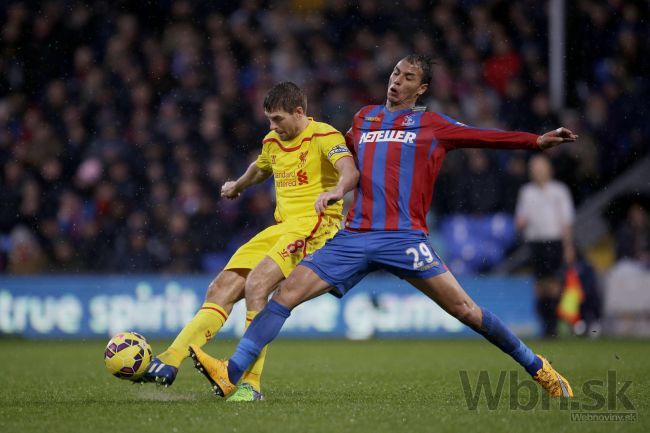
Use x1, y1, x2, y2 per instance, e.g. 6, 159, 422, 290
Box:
228, 299, 291, 383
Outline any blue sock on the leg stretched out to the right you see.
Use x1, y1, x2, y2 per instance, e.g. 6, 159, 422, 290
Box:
474, 308, 542, 376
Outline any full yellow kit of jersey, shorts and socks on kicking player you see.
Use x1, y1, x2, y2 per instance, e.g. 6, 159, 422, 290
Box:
156, 118, 351, 386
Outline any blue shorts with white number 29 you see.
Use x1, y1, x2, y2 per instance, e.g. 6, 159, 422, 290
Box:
299, 230, 447, 297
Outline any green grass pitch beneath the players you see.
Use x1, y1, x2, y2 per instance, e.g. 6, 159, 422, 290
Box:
0, 339, 650, 433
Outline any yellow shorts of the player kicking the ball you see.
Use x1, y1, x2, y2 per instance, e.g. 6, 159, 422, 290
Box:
225, 215, 341, 277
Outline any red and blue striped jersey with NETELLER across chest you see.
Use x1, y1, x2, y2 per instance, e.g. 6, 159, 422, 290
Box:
345, 105, 538, 233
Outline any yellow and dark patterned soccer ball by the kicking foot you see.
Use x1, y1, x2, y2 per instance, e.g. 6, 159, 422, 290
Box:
104, 332, 151, 380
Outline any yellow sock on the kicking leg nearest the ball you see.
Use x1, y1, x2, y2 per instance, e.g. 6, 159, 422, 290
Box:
158, 302, 228, 367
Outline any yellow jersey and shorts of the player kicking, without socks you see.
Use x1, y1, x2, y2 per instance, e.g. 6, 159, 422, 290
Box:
225, 118, 352, 277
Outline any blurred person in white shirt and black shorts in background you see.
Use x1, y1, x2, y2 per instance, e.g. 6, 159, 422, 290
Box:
515, 154, 575, 337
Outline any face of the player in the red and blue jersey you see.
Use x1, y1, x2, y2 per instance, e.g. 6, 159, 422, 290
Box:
386, 59, 428, 108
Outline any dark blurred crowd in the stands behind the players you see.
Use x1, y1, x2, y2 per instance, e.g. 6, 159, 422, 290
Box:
0, 0, 650, 273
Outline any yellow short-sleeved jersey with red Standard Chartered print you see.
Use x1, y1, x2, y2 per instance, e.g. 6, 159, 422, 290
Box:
256, 117, 352, 222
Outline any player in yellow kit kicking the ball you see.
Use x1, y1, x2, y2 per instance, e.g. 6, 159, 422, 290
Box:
143, 82, 359, 401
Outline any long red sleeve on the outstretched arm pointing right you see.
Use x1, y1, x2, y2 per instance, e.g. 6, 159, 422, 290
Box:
430, 113, 539, 150
